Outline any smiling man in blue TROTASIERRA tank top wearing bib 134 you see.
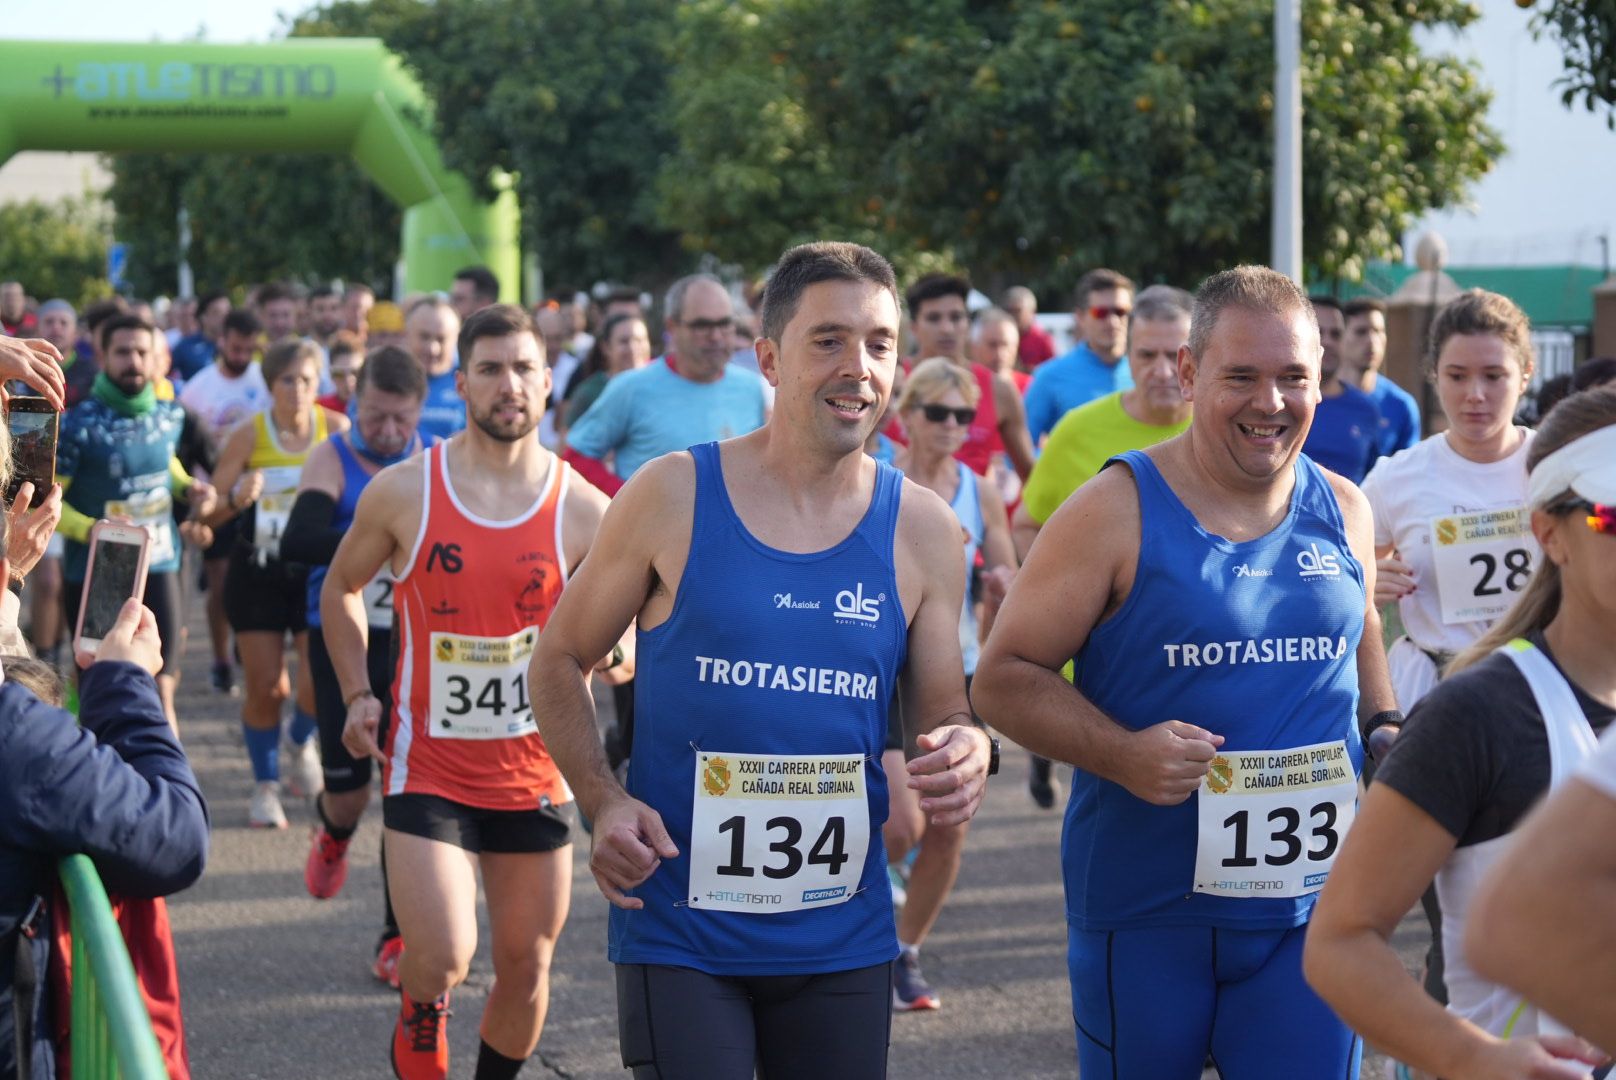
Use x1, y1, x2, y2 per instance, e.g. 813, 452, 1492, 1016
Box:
530, 244, 992, 1080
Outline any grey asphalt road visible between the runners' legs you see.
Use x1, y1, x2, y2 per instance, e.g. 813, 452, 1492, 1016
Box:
160, 603, 1425, 1080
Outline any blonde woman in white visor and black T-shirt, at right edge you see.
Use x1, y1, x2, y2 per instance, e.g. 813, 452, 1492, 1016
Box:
1306, 390, 1616, 1080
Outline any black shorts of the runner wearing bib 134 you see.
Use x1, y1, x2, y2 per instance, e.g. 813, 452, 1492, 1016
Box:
617, 964, 892, 1080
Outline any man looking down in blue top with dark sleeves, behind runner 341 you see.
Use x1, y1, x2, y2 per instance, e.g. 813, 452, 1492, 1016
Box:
281, 346, 436, 988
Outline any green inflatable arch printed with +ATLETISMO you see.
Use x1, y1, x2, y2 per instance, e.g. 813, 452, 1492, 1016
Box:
0, 37, 520, 301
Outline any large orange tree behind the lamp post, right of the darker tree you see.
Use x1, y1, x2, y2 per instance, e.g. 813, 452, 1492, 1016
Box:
659, 0, 1503, 288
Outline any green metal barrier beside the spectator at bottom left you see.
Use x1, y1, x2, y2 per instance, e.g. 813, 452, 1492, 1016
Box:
58, 855, 168, 1080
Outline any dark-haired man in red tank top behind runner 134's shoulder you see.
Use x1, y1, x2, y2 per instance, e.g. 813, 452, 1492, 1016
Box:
903, 273, 1033, 479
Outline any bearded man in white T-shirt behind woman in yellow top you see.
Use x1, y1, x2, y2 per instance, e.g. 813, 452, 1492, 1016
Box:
179, 309, 270, 694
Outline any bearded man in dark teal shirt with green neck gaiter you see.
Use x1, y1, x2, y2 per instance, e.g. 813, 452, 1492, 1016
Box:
57, 312, 213, 721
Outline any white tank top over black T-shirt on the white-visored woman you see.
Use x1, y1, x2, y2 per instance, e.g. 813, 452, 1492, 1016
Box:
1437, 639, 1598, 1038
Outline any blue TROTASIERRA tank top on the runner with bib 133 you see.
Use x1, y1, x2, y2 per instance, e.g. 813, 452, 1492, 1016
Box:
1062, 449, 1366, 930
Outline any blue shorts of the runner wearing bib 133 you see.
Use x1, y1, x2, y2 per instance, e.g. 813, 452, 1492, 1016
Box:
1067, 925, 1362, 1080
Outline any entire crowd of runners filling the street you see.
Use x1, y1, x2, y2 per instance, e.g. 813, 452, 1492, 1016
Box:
0, 243, 1616, 1080
